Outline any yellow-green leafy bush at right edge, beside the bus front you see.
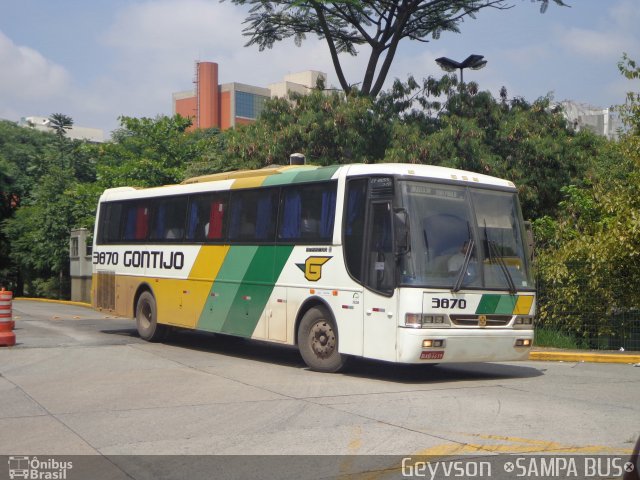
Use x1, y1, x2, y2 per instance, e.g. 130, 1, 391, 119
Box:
534, 56, 640, 344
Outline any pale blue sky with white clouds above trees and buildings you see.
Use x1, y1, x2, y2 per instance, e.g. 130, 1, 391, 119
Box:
0, 0, 640, 137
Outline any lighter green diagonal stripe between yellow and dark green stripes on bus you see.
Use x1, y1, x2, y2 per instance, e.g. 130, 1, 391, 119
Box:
197, 246, 258, 332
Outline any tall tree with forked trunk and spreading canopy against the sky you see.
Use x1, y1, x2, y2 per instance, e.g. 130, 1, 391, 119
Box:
232, 0, 566, 97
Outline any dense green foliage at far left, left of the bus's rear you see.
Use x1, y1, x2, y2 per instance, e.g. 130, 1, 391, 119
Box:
0, 114, 97, 297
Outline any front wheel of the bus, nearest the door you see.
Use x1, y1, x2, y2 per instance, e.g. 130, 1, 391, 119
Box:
298, 307, 347, 373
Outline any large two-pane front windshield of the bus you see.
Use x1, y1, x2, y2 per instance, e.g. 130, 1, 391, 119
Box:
399, 181, 534, 293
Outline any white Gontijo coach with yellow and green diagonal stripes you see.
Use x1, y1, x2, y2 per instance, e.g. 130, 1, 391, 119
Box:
92, 164, 536, 372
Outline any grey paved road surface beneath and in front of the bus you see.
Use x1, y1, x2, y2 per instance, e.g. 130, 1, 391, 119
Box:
0, 301, 640, 478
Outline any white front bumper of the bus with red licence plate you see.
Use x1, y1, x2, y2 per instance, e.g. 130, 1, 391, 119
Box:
397, 328, 533, 363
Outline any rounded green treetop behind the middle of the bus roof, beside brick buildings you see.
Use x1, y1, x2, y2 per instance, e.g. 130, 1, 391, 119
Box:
205, 90, 390, 171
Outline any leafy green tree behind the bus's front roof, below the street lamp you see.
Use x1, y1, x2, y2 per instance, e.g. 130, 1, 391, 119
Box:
378, 77, 596, 218
